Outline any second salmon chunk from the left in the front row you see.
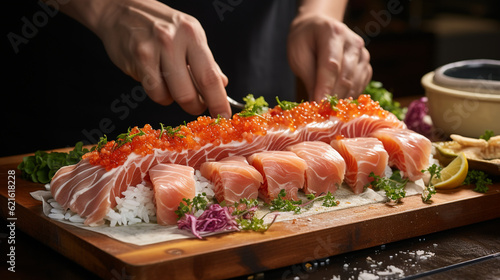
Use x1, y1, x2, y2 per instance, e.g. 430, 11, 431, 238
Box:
200, 156, 264, 204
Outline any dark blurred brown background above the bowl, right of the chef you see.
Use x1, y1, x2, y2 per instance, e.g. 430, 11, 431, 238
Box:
345, 0, 500, 97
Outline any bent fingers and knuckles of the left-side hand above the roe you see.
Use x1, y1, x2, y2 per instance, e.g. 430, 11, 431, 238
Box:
138, 12, 231, 118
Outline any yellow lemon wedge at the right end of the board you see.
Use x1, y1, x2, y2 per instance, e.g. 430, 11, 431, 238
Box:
432, 153, 469, 189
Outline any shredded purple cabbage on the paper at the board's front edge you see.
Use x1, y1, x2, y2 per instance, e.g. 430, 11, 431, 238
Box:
177, 204, 239, 239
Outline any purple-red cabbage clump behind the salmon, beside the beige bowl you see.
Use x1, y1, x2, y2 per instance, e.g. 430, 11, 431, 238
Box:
404, 97, 432, 137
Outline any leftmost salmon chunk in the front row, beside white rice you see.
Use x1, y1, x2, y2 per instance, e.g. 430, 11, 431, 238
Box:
149, 163, 196, 225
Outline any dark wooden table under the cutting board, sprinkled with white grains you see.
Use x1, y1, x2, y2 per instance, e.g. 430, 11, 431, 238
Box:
0, 219, 500, 280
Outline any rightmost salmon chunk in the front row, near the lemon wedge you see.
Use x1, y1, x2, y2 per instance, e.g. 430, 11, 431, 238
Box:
371, 128, 432, 181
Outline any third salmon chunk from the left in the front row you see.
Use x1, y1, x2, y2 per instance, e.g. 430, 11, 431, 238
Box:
248, 151, 307, 203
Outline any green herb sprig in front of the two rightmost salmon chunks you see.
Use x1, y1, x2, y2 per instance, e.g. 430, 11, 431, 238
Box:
369, 170, 409, 204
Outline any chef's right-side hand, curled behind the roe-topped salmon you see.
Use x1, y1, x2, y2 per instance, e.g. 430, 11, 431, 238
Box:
288, 0, 372, 101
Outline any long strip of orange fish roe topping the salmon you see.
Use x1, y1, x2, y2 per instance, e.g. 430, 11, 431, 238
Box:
83, 95, 389, 170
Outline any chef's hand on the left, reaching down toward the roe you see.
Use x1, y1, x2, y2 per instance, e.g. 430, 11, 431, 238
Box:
48, 0, 231, 117
